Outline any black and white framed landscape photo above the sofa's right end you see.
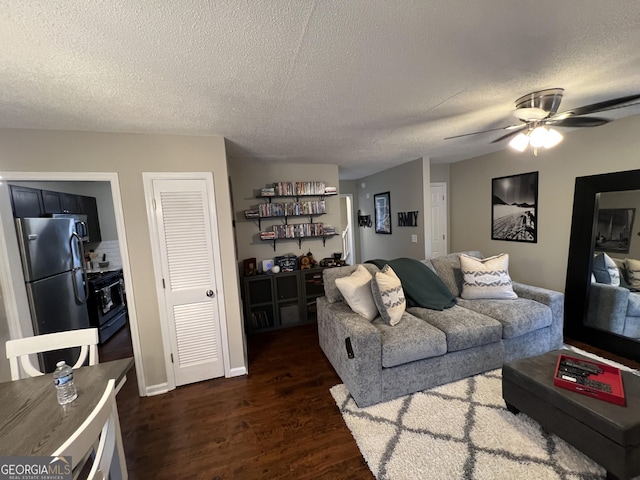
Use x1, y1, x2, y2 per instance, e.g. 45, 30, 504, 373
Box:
491, 172, 538, 243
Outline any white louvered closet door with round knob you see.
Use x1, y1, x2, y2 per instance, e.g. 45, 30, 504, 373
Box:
153, 179, 224, 386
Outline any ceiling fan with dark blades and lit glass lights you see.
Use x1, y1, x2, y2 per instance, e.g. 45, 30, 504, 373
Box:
445, 88, 640, 154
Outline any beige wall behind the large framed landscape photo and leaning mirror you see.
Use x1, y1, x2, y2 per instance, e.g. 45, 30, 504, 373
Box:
449, 116, 640, 291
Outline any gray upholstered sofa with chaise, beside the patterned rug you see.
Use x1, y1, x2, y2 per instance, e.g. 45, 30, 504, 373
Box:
317, 252, 564, 407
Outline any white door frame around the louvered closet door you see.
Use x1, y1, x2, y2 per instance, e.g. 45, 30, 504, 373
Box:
142, 172, 234, 391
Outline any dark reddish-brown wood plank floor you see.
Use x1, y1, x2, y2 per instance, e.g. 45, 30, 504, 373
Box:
100, 324, 640, 480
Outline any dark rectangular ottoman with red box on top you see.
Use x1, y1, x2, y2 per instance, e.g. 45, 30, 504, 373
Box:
502, 350, 640, 480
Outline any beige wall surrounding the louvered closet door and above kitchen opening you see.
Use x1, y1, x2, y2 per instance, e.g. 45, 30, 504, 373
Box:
0, 129, 246, 386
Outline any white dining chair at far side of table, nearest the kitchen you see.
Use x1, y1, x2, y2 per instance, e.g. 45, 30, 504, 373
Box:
6, 328, 98, 380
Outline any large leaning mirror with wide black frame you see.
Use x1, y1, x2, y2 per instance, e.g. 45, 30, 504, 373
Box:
565, 170, 640, 360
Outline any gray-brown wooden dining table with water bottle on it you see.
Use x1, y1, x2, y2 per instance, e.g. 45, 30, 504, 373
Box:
0, 358, 133, 456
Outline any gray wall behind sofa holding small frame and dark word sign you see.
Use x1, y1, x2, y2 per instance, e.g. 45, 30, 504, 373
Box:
357, 159, 430, 261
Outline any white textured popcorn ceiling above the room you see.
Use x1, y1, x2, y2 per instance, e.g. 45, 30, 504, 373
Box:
0, 0, 640, 178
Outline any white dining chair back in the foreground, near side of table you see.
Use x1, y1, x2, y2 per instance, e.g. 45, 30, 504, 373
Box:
53, 379, 126, 480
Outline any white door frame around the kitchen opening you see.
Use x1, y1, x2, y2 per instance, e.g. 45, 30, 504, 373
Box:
0, 172, 148, 397
